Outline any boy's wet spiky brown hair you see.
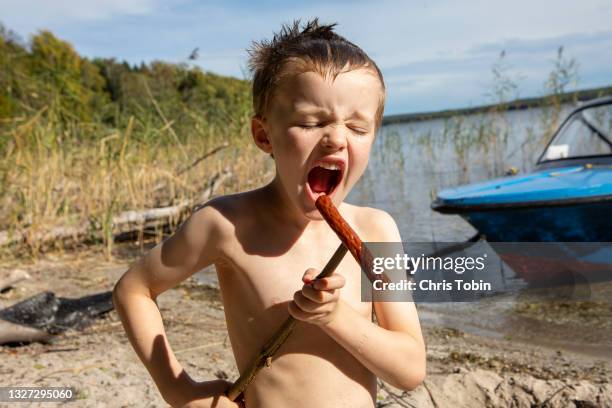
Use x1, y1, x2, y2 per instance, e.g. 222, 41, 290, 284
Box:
248, 18, 385, 128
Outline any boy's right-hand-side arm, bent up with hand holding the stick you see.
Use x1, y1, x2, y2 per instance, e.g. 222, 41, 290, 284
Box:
290, 211, 426, 390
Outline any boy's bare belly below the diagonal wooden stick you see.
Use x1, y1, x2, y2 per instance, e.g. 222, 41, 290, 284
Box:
245, 323, 376, 408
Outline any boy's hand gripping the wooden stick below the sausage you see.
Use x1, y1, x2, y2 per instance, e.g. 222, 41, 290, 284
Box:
289, 268, 345, 325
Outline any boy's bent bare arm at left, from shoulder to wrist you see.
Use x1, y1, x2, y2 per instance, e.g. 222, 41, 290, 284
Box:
113, 207, 232, 406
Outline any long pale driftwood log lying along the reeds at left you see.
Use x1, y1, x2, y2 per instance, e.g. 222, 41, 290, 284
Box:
0, 169, 232, 246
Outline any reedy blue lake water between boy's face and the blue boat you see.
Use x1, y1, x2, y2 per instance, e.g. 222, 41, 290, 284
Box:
347, 106, 571, 242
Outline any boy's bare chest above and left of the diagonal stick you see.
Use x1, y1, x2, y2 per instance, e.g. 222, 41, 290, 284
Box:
216, 233, 372, 367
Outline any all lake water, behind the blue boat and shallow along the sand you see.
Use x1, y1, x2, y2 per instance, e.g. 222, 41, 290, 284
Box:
198, 105, 612, 355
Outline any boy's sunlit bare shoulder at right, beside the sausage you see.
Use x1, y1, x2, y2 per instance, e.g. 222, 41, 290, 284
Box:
340, 203, 401, 242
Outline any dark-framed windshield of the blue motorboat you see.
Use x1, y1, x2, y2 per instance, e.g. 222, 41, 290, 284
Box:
541, 104, 612, 161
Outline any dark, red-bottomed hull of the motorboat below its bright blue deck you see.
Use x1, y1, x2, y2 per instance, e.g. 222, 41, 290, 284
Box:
461, 200, 612, 285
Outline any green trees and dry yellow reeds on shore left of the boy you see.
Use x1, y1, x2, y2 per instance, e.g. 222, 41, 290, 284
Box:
0, 23, 280, 256
